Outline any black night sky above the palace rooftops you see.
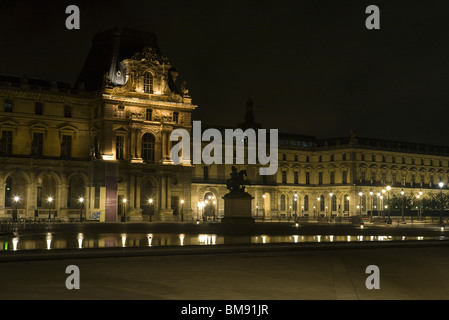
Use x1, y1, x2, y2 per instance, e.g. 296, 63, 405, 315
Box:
0, 0, 449, 145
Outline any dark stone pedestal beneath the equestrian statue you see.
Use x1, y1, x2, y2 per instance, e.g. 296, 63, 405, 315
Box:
221, 192, 254, 223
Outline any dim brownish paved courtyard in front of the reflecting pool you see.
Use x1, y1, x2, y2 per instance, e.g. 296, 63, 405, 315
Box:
0, 245, 449, 300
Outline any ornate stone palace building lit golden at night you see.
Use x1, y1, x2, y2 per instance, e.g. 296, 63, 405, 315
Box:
0, 28, 449, 221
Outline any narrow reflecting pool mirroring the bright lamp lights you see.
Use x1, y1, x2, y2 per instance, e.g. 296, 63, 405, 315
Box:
0, 233, 448, 251
